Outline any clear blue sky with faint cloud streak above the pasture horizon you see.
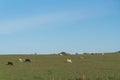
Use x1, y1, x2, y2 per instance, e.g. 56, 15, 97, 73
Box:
0, 0, 120, 54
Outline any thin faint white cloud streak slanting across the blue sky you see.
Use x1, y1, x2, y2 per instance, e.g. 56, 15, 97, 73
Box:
0, 8, 108, 34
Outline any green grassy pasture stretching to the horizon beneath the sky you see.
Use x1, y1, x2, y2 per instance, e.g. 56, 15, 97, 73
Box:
0, 54, 120, 80
